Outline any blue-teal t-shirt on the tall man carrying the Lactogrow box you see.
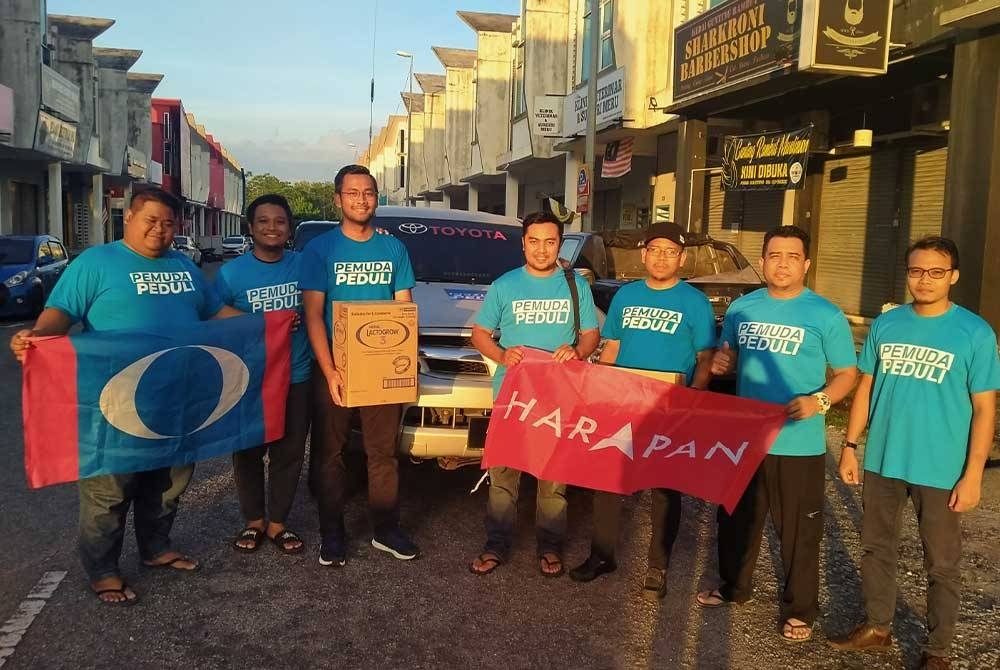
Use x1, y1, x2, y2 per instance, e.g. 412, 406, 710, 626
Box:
299, 226, 415, 333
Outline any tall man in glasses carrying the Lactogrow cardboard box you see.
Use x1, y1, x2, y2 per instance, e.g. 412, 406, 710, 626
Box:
299, 165, 420, 567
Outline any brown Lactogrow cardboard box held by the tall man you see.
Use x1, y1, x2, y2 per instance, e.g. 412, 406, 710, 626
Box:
332, 300, 419, 407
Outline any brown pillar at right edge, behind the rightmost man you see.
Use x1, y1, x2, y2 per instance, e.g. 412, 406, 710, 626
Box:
942, 31, 1000, 330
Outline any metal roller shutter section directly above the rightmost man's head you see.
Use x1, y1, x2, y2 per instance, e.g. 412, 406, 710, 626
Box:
895, 142, 948, 302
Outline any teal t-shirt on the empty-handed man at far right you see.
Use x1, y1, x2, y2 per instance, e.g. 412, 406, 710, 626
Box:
858, 305, 1000, 490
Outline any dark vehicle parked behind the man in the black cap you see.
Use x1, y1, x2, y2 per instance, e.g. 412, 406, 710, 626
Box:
559, 230, 763, 325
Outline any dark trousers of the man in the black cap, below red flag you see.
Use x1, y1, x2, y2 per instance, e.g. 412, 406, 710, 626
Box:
590, 489, 681, 570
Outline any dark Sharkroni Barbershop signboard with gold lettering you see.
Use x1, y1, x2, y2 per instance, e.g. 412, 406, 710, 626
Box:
673, 0, 802, 103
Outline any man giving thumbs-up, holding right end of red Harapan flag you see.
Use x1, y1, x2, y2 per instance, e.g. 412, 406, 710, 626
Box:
697, 226, 857, 642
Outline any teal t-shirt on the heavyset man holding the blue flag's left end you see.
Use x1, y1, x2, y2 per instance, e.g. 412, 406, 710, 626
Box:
45, 240, 222, 331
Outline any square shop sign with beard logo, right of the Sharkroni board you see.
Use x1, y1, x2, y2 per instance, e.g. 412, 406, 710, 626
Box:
799, 0, 893, 76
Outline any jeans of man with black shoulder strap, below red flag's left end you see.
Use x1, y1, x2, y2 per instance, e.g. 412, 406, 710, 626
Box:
485, 468, 566, 560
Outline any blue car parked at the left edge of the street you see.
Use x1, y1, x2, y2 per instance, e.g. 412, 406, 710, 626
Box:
0, 235, 69, 316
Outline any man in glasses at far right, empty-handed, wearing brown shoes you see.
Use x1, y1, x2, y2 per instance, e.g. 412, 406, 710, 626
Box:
831, 237, 1000, 668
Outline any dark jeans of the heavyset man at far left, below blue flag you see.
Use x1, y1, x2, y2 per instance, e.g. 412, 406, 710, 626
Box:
79, 465, 194, 582
